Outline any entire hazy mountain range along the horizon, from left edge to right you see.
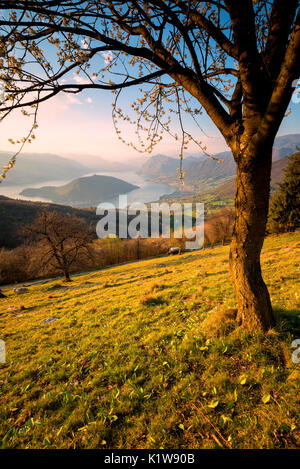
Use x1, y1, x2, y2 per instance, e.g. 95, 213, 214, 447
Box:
0, 134, 300, 194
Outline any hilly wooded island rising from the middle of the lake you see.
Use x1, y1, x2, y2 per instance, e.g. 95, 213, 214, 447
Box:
20, 175, 138, 207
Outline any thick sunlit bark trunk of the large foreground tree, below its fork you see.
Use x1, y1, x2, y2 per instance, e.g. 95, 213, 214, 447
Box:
230, 143, 275, 331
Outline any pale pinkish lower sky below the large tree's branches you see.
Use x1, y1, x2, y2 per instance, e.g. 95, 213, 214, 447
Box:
0, 78, 300, 163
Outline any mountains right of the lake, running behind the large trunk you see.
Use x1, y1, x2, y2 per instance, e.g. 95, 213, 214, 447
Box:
139, 134, 300, 193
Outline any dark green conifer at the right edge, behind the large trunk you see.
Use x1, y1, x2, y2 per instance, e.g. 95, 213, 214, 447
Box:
269, 151, 300, 231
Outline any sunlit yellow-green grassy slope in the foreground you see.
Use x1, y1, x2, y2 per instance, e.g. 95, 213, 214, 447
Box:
0, 233, 300, 448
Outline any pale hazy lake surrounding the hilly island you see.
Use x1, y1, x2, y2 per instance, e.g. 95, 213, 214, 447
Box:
0, 171, 175, 208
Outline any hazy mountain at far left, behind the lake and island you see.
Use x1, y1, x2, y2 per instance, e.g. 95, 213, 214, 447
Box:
0, 151, 90, 189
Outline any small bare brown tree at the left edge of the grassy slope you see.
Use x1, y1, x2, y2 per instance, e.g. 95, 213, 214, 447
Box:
24, 211, 93, 282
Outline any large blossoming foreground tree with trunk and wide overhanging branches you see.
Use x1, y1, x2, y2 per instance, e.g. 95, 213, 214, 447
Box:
0, 0, 300, 330
